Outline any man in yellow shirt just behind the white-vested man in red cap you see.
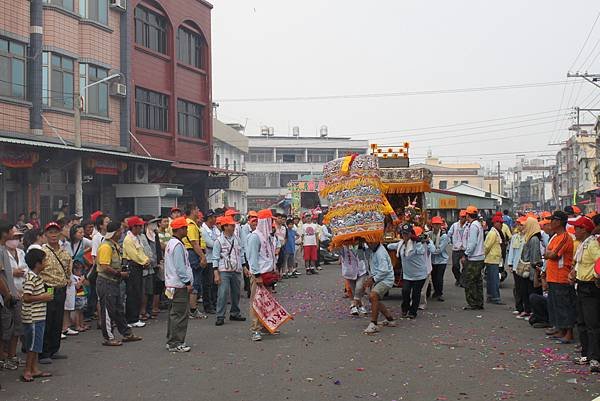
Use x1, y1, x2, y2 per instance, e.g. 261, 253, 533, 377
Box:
182, 203, 210, 318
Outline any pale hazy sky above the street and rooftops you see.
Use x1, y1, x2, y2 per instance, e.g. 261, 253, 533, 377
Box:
212, 0, 600, 166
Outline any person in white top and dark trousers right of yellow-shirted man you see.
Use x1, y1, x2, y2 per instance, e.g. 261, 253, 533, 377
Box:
202, 210, 220, 315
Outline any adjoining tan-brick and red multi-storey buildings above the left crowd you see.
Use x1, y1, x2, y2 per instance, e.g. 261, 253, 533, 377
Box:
0, 0, 212, 220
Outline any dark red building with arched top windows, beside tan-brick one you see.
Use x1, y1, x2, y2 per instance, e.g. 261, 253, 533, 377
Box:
129, 0, 212, 211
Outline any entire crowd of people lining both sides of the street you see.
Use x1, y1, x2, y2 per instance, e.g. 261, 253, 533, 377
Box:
0, 204, 600, 382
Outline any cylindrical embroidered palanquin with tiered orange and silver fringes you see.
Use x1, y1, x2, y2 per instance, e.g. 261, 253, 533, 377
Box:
321, 155, 390, 247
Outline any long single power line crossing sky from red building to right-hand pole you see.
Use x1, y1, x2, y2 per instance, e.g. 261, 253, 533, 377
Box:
215, 81, 564, 103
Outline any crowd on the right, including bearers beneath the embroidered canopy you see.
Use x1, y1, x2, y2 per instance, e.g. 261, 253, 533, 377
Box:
340, 206, 600, 373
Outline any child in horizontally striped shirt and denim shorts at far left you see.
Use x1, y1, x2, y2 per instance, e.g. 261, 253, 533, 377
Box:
21, 249, 54, 382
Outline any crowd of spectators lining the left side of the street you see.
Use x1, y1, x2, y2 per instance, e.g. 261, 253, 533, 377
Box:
0, 204, 330, 382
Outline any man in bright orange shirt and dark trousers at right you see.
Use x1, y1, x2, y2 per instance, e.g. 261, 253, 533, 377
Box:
545, 210, 577, 344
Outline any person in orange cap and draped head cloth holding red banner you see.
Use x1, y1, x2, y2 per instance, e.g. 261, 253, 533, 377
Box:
246, 209, 277, 341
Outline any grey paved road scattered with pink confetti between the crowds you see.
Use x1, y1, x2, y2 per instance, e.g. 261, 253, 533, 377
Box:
0, 266, 600, 401
